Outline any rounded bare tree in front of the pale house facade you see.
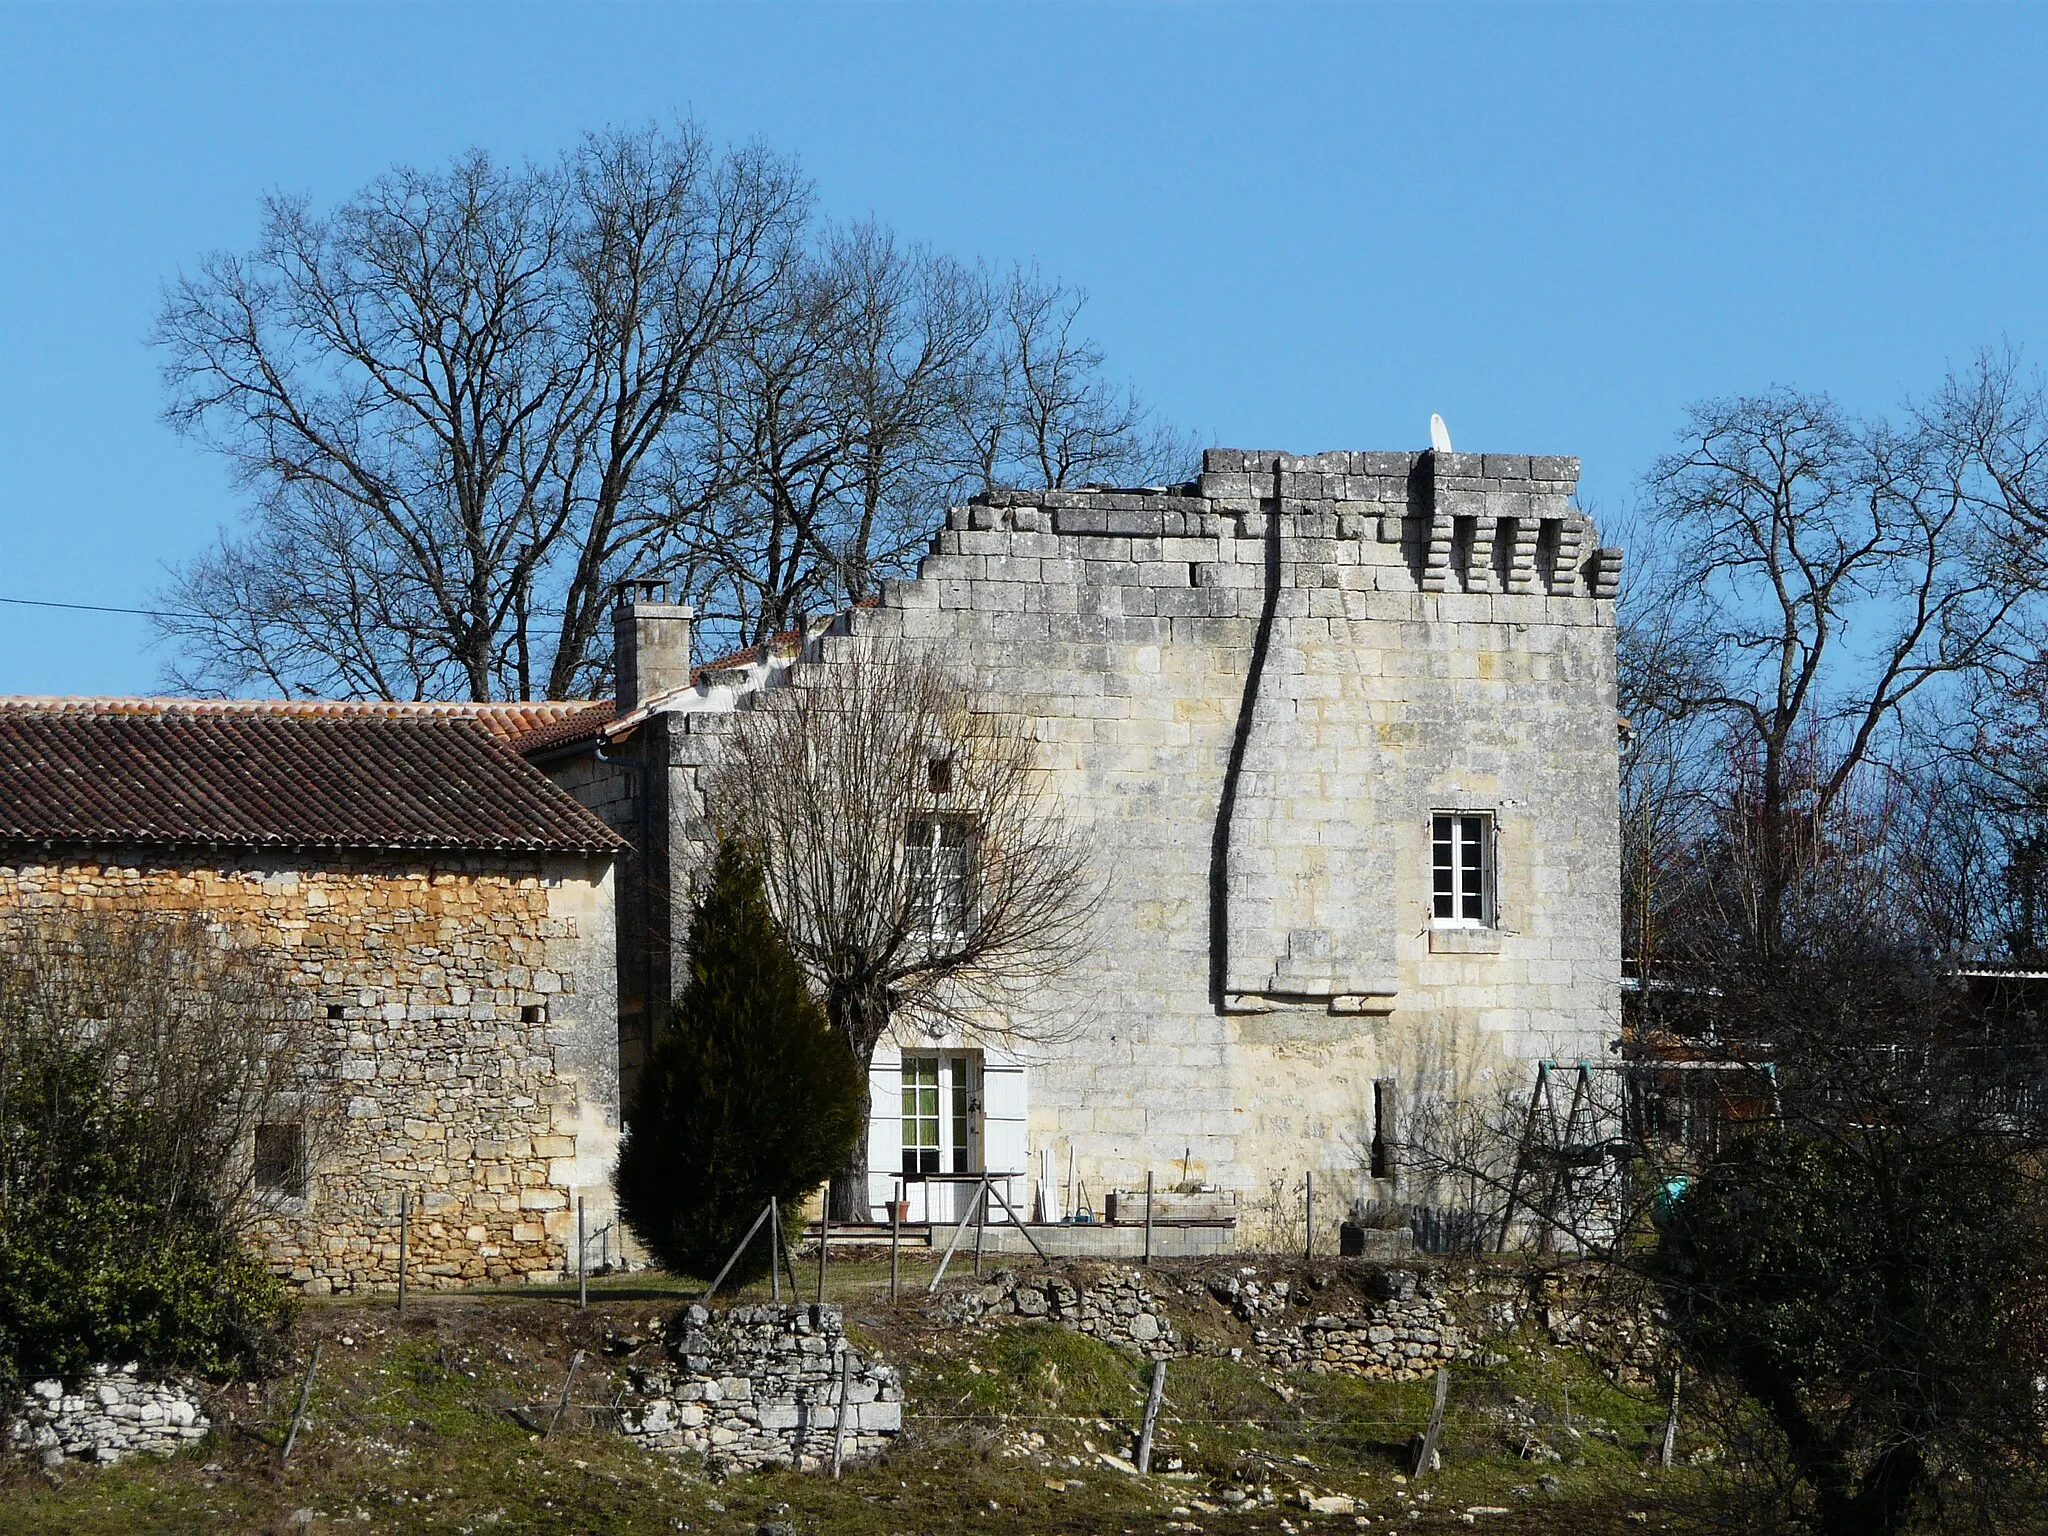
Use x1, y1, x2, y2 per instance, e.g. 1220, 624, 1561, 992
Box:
707, 641, 1100, 1219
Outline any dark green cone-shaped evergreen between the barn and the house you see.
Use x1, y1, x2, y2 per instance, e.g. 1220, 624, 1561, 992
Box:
614, 842, 866, 1280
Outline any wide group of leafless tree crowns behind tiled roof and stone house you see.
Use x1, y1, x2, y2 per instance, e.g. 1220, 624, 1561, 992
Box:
156, 123, 1192, 698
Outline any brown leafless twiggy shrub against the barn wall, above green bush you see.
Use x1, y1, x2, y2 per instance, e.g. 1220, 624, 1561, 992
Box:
0, 913, 338, 1225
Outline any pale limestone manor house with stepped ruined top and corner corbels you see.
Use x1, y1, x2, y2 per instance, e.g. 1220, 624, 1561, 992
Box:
522, 449, 1622, 1245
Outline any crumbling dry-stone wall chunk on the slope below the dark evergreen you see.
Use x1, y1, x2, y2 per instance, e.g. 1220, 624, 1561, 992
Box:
621, 1305, 903, 1473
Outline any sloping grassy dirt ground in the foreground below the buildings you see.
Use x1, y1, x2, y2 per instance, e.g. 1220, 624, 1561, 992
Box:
0, 1255, 1759, 1536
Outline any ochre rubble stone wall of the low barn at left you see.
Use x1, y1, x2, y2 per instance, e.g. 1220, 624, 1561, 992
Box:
0, 850, 618, 1294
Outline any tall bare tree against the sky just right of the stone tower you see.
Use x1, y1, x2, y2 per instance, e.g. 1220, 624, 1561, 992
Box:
1645, 389, 2030, 952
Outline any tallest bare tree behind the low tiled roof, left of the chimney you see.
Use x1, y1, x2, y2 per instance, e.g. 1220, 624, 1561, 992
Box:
158, 123, 809, 698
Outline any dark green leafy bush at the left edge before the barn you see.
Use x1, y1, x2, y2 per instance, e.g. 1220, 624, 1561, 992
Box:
0, 1036, 291, 1395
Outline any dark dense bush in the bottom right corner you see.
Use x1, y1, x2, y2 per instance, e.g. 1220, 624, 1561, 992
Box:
1655, 1126, 2048, 1534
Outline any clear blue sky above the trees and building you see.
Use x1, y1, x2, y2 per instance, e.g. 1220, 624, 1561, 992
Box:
0, 0, 2048, 692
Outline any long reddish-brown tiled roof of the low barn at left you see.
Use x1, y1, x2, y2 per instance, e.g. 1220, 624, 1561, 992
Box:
0, 698, 623, 852
